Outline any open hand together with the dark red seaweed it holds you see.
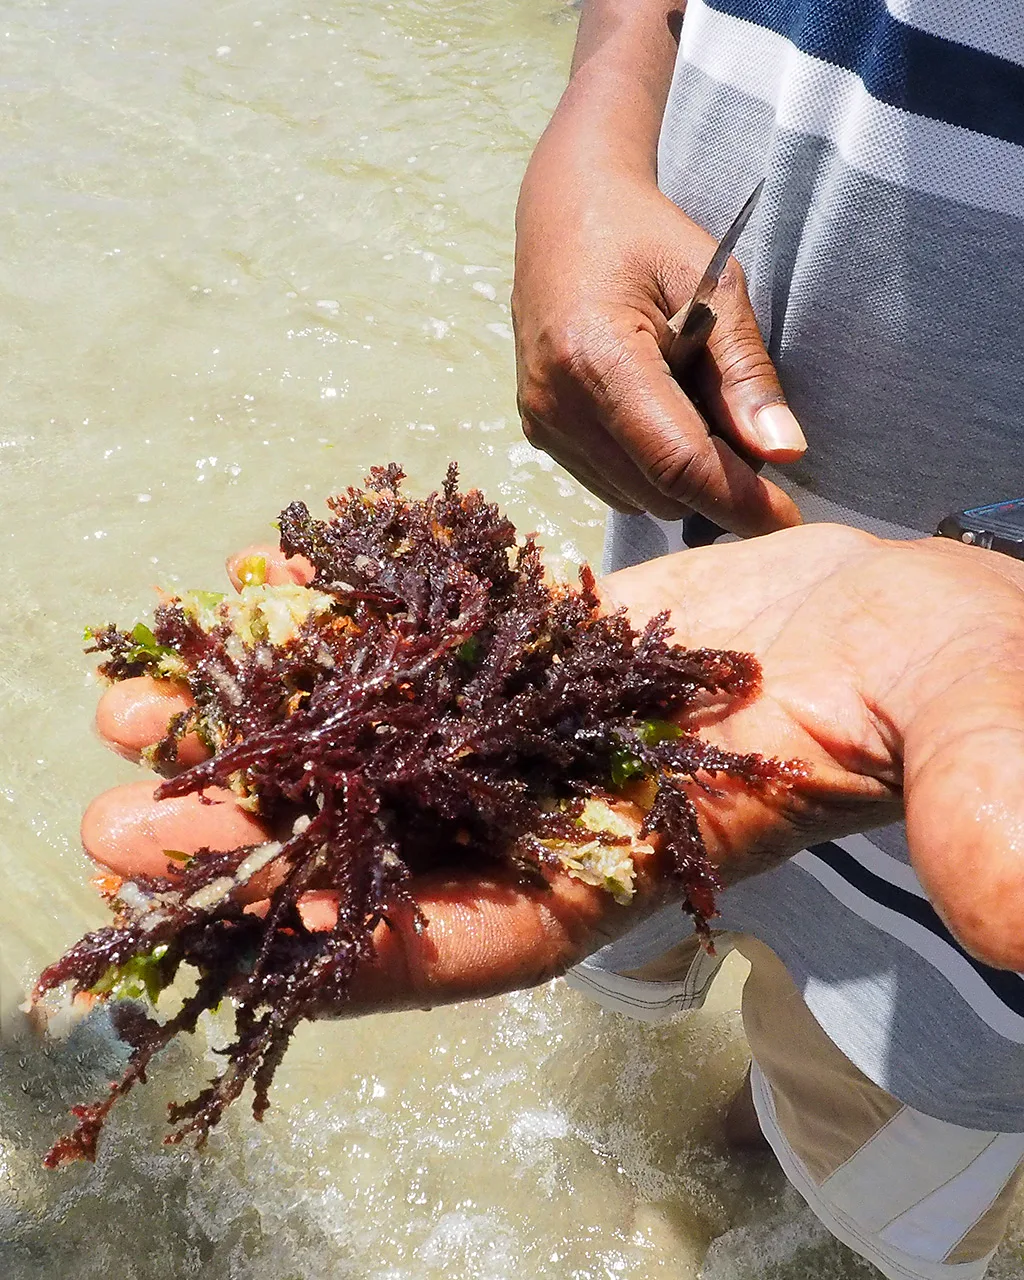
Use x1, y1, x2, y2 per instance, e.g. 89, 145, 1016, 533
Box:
32, 472, 1024, 1162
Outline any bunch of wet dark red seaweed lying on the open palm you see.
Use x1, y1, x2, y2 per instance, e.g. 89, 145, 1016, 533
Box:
35, 466, 786, 1166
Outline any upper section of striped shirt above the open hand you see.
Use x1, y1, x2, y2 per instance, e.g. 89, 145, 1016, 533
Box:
659, 0, 1024, 532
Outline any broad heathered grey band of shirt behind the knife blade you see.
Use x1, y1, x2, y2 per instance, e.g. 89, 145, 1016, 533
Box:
659, 67, 1024, 531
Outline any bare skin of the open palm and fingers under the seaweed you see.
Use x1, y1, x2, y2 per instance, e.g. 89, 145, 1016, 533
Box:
83, 525, 1024, 1014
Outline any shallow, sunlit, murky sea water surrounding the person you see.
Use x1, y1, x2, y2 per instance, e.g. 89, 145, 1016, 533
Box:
0, 0, 1020, 1280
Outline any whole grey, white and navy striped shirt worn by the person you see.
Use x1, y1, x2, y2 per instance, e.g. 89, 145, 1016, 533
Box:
588, 0, 1024, 1133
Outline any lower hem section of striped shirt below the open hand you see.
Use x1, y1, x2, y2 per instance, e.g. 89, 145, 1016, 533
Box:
716, 827, 1024, 1133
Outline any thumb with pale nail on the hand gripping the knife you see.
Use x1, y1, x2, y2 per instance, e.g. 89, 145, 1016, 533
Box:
694, 262, 808, 462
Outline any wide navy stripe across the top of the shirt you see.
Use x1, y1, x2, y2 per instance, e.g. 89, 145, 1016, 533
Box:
705, 0, 1024, 146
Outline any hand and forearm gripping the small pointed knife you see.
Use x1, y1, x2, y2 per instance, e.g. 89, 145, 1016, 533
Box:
512, 0, 806, 535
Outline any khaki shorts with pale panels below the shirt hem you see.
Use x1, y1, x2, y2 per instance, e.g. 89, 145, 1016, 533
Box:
568, 934, 1024, 1280
